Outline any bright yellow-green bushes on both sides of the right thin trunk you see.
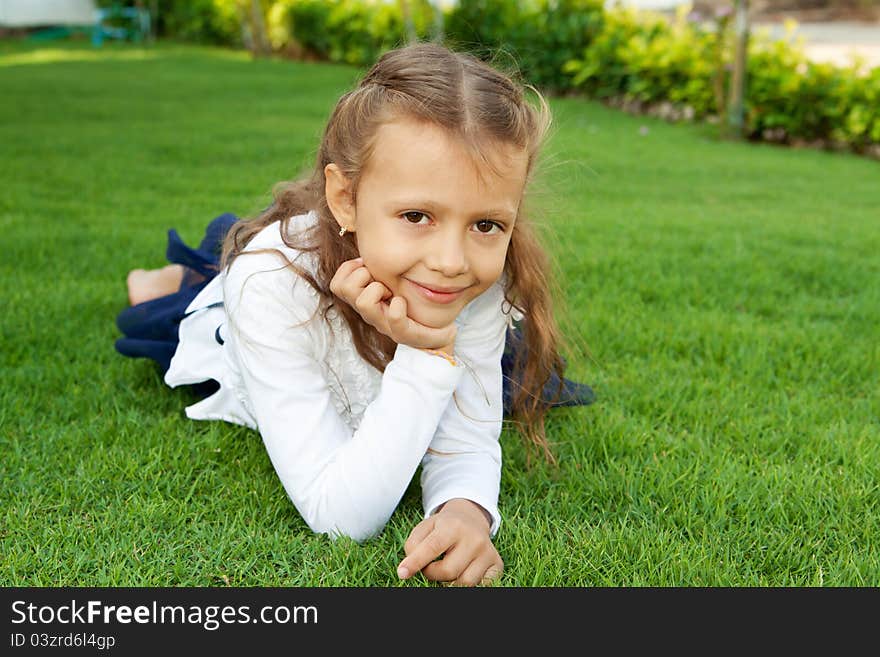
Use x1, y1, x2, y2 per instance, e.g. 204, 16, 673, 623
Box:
563, 8, 880, 151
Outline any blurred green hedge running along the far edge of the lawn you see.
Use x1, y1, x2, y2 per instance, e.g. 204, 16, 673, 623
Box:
99, 0, 880, 155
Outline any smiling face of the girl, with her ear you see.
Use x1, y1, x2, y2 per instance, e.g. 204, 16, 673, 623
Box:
325, 118, 528, 328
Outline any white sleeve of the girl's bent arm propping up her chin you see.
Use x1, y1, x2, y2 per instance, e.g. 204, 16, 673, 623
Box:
224, 254, 464, 541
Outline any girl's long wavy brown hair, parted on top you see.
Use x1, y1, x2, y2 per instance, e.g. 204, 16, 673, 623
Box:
221, 43, 568, 463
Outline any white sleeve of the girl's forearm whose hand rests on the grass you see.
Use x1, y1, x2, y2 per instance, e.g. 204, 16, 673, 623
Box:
421, 283, 508, 537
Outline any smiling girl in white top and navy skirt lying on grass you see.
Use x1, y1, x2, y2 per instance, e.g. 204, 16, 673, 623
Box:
116, 39, 593, 585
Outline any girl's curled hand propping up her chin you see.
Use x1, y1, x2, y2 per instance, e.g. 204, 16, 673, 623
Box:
330, 258, 456, 354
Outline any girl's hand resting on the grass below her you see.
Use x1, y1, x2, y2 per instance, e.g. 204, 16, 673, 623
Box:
397, 498, 504, 586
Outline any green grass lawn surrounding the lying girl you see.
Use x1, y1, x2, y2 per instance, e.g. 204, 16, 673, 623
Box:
0, 41, 880, 586
